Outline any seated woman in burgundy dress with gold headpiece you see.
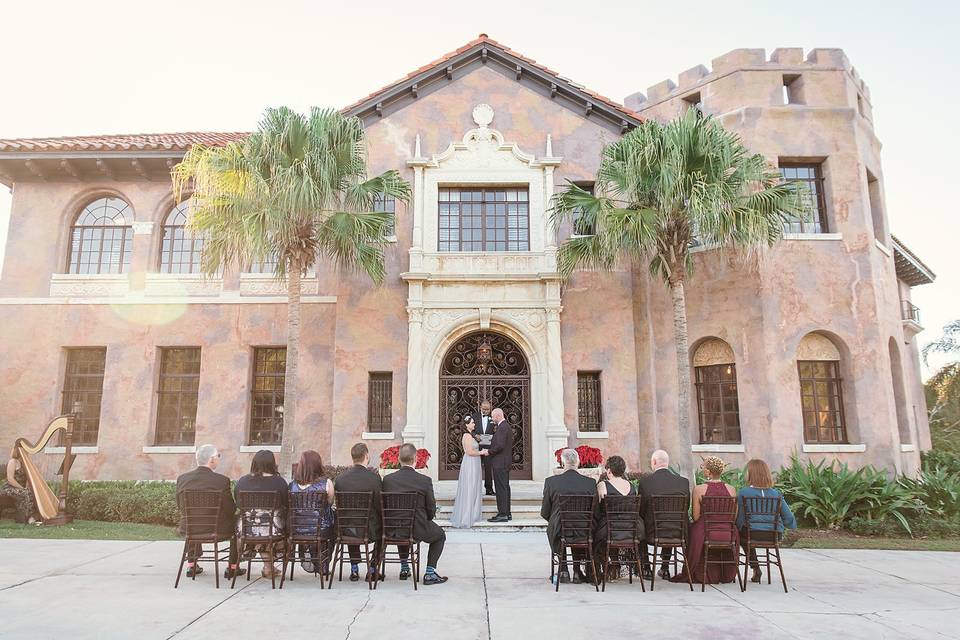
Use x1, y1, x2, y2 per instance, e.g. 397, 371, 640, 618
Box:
673, 456, 737, 584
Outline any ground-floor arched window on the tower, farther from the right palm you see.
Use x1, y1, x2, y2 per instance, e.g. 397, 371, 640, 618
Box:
797, 333, 847, 444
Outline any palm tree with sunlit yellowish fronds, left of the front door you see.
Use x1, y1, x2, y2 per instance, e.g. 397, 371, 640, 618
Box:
172, 107, 410, 470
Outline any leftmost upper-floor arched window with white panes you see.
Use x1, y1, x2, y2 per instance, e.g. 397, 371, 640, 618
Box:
68, 198, 133, 273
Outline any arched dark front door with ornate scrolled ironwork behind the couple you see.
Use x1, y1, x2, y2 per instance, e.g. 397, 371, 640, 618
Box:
439, 331, 533, 480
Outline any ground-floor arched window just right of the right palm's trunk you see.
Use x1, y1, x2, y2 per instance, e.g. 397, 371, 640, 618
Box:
693, 338, 740, 444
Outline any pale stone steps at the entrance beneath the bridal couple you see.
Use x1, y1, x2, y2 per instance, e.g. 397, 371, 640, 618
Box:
434, 480, 547, 533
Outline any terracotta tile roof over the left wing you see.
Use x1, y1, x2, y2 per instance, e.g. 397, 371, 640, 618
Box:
0, 131, 249, 153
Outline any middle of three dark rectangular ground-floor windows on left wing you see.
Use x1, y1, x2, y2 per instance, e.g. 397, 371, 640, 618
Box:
156, 347, 200, 445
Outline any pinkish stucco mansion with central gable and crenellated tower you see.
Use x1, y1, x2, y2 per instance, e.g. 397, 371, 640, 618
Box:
0, 35, 934, 480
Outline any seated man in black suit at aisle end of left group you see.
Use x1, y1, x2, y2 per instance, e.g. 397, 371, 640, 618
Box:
383, 442, 447, 585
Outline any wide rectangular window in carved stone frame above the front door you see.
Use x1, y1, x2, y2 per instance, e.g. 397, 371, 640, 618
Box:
437, 187, 530, 251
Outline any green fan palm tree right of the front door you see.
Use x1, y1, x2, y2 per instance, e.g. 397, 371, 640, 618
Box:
551, 109, 809, 477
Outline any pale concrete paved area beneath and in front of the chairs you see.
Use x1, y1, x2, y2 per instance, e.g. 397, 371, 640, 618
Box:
0, 532, 960, 640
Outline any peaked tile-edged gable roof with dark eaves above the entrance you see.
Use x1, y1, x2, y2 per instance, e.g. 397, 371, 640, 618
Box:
343, 33, 643, 132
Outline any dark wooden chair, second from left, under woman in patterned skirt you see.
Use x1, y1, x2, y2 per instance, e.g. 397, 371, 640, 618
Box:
230, 491, 287, 589
